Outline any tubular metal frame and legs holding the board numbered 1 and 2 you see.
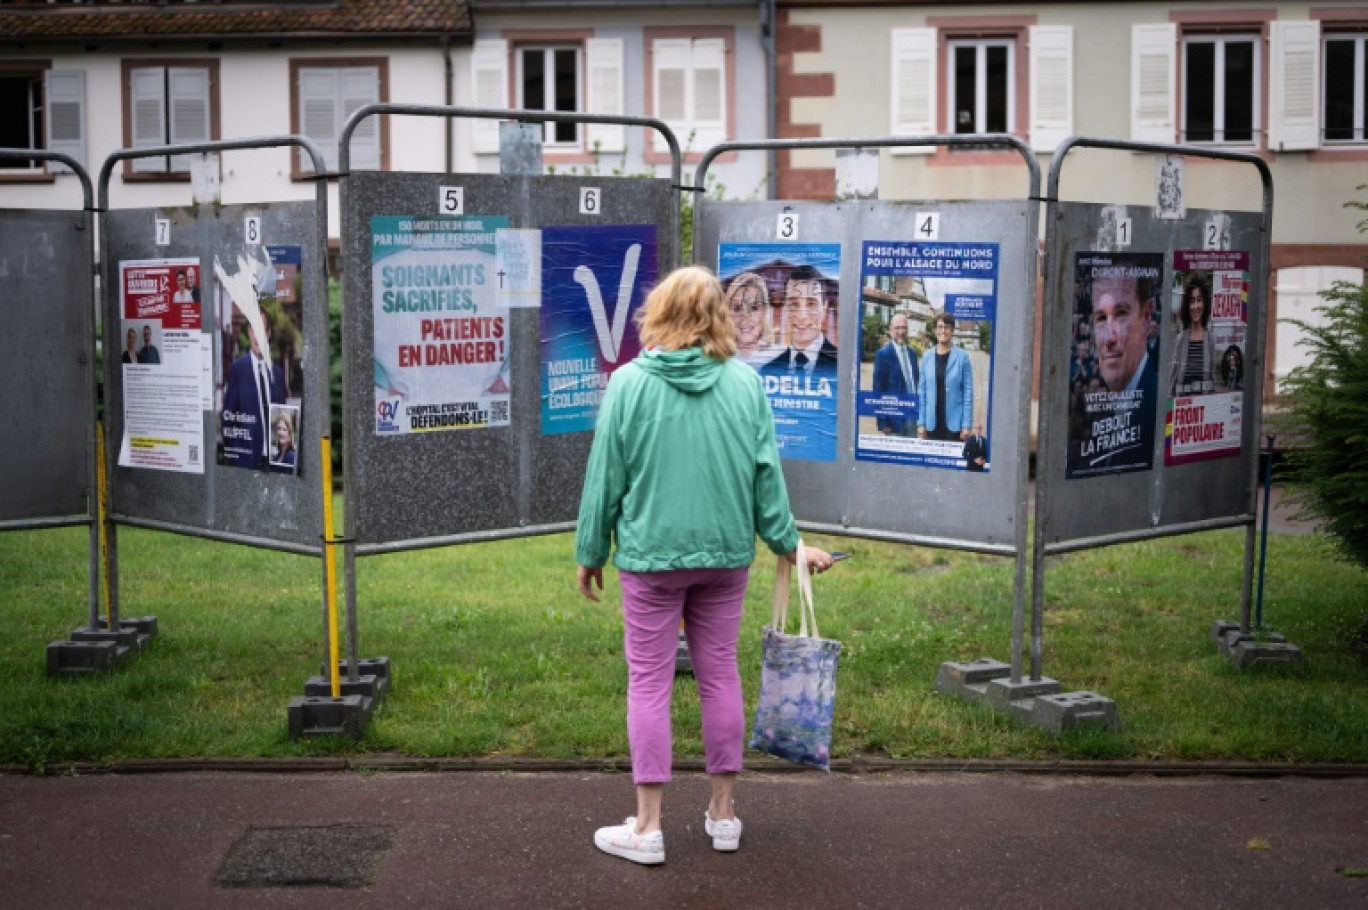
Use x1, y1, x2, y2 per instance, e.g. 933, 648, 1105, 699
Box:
1034, 135, 1274, 683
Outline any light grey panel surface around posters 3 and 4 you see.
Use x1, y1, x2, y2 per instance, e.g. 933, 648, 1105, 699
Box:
695, 200, 1036, 553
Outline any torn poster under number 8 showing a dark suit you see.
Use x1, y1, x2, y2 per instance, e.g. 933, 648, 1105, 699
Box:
213, 244, 304, 473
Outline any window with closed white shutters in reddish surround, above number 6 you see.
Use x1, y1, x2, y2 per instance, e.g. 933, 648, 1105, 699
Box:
651, 37, 728, 153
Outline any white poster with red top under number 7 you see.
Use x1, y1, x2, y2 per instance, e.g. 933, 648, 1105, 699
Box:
118, 251, 208, 473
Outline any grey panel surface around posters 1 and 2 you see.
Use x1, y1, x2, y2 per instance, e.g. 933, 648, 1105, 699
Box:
1037, 203, 1268, 551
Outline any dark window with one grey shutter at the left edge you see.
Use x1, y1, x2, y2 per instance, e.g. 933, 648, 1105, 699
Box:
0, 63, 85, 178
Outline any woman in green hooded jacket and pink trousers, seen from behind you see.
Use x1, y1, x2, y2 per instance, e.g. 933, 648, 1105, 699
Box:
575, 265, 832, 863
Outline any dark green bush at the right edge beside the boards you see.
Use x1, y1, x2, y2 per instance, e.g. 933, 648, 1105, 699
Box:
1280, 186, 1368, 568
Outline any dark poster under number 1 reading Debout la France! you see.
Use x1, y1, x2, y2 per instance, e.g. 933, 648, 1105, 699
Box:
1064, 252, 1164, 480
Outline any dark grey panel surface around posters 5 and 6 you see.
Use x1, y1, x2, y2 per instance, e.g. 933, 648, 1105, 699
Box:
343, 171, 677, 554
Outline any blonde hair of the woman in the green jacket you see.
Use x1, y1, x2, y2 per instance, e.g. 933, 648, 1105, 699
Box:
636, 265, 736, 360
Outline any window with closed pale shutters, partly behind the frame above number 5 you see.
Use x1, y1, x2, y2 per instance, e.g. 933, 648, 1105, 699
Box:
290, 59, 387, 178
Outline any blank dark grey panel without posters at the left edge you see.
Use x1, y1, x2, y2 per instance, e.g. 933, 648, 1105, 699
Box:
0, 211, 94, 521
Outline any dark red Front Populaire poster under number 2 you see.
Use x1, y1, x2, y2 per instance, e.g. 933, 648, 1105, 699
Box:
1164, 250, 1249, 465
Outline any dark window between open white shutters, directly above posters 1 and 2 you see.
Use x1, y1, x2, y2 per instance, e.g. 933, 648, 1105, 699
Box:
1182, 36, 1261, 145
